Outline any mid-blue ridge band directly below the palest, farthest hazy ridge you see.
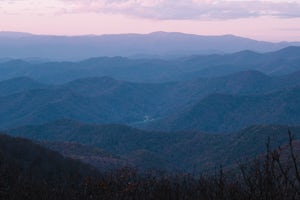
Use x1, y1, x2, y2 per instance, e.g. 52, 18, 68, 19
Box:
0, 46, 300, 84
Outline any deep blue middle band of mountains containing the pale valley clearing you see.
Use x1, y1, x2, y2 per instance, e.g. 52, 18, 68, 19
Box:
0, 68, 300, 132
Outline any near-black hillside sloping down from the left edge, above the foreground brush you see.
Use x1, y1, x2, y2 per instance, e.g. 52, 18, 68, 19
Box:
0, 134, 97, 181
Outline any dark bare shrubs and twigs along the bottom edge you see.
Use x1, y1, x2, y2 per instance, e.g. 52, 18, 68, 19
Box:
0, 131, 300, 200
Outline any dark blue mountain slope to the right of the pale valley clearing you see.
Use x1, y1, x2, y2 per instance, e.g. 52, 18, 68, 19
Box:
148, 87, 300, 132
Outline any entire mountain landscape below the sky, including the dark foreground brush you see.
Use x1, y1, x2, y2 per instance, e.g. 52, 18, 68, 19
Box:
0, 32, 300, 199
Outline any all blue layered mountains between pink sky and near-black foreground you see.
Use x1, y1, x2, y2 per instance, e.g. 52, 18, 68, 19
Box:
0, 33, 300, 172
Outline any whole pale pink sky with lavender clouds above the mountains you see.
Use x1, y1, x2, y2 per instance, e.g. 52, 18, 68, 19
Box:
0, 0, 300, 42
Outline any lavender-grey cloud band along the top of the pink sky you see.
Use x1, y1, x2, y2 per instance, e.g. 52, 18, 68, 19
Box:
0, 0, 300, 20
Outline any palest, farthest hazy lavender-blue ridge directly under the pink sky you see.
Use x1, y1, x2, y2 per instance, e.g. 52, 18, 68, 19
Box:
0, 32, 300, 60
